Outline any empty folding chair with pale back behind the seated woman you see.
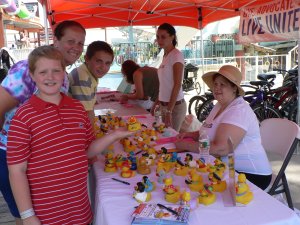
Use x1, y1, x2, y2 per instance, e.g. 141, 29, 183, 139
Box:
260, 118, 300, 209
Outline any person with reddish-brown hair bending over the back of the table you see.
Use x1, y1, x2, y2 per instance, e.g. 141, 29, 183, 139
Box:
120, 60, 159, 110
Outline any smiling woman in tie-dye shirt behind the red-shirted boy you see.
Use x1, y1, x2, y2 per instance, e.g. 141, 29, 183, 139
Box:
0, 20, 86, 224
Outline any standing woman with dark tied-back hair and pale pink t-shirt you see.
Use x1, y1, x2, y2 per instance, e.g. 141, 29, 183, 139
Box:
156, 23, 187, 131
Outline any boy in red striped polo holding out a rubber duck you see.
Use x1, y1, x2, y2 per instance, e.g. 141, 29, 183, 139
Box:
7, 46, 132, 225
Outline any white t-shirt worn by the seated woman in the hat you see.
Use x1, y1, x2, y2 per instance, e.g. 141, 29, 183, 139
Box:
202, 97, 272, 175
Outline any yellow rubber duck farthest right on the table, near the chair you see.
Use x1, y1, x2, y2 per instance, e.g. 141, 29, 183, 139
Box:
235, 173, 253, 205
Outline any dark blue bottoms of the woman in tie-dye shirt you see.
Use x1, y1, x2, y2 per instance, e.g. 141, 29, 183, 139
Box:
0, 149, 20, 218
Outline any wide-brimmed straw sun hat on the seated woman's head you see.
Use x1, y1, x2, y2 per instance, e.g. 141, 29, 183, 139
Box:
202, 65, 245, 96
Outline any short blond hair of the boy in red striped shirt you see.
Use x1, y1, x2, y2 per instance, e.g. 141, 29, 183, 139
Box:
28, 45, 66, 73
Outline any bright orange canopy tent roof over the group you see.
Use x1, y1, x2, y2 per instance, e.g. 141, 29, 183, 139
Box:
40, 0, 272, 29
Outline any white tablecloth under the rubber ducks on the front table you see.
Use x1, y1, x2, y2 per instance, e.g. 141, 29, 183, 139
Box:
93, 115, 300, 225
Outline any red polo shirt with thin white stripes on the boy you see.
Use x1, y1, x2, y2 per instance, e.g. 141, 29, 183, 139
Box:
7, 94, 94, 224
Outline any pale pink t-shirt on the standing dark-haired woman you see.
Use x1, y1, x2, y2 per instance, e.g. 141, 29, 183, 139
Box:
157, 48, 184, 102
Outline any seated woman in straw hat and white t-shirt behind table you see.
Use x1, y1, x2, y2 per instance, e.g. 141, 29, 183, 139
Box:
177, 65, 272, 190
